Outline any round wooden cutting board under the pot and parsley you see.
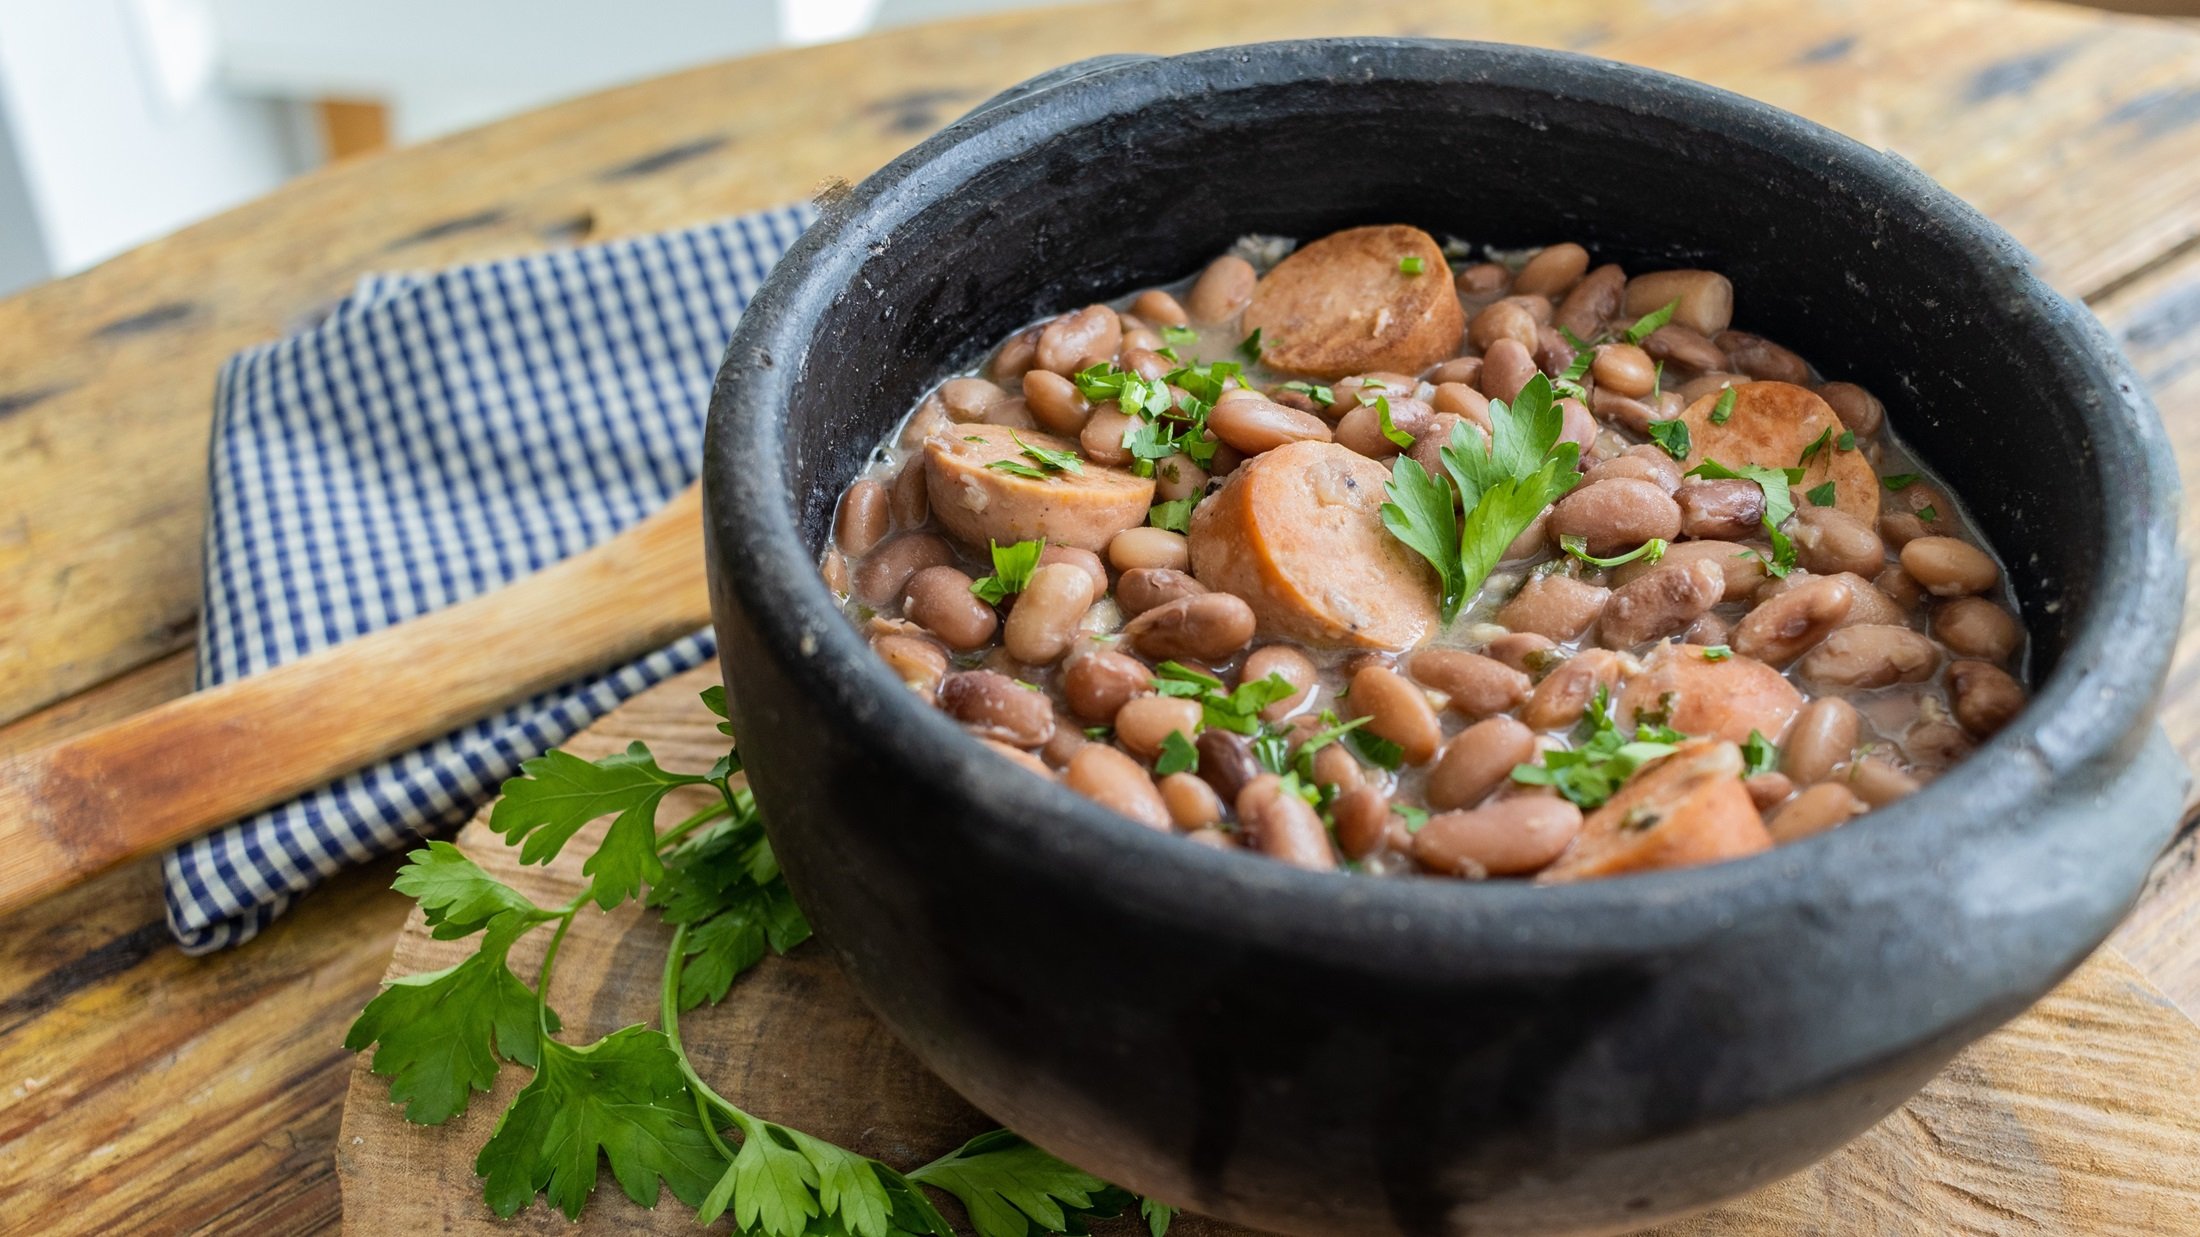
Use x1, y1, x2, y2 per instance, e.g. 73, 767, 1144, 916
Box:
337, 667, 2200, 1237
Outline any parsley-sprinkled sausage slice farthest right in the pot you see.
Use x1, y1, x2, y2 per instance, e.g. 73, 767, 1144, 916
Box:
1681, 383, 1879, 526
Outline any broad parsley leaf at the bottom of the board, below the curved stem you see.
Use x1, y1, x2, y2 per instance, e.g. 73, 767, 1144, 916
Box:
473, 1026, 724, 1219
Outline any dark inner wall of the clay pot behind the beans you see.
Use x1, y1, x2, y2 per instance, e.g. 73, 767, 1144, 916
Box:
790, 66, 2105, 676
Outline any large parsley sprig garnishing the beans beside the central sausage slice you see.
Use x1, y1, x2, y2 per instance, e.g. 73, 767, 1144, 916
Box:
1382, 365, 1582, 623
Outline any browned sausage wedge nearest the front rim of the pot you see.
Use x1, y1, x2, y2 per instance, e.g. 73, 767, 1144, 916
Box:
1536, 742, 1773, 883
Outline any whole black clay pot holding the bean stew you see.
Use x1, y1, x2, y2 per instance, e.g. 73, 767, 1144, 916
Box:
706, 40, 2185, 1235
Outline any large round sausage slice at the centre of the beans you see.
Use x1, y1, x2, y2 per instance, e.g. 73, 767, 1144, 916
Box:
1192, 442, 1437, 649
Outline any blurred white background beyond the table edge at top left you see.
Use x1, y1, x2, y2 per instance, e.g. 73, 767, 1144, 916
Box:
0, 0, 1032, 295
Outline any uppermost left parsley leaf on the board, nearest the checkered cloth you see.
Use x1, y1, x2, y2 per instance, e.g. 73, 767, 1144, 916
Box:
488, 744, 706, 909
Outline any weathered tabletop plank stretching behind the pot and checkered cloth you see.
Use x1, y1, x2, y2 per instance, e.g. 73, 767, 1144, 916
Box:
0, 0, 2200, 720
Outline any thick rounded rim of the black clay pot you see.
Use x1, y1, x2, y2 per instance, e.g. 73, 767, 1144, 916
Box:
704, 37, 2185, 968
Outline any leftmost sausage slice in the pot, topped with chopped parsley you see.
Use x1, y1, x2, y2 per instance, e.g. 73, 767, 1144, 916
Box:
924, 425, 1153, 550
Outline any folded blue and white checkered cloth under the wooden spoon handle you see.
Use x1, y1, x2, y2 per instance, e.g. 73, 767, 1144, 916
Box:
163, 205, 812, 953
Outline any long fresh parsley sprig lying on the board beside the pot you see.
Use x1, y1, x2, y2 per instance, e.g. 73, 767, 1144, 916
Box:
343, 686, 1175, 1237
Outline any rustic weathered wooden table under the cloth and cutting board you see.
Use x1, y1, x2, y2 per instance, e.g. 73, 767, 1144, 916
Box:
0, 0, 2200, 1233
